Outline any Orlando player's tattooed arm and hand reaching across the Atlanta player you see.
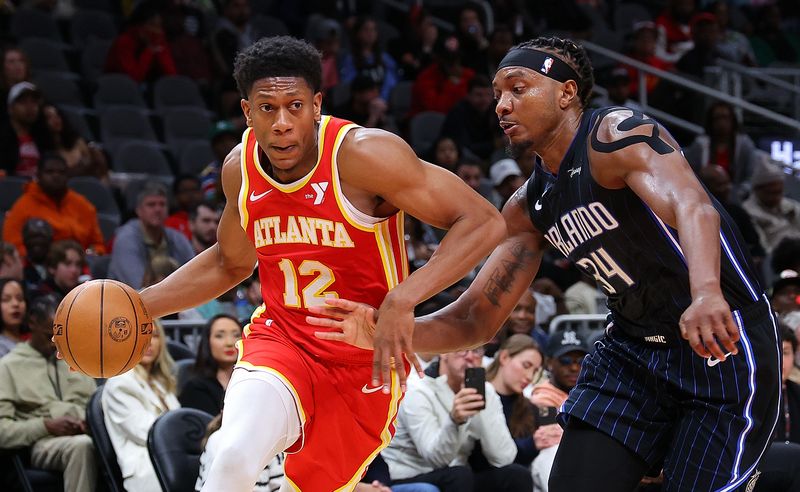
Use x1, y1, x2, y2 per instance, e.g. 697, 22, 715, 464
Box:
308, 186, 544, 353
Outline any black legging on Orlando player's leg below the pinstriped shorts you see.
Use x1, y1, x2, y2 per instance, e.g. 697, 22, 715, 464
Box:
549, 417, 648, 492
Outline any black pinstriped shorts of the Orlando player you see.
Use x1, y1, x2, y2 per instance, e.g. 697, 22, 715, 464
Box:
562, 298, 782, 492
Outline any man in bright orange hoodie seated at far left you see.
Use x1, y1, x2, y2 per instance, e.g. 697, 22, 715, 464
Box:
3, 154, 106, 255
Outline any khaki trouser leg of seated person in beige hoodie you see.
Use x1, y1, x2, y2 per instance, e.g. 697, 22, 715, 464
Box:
31, 434, 97, 492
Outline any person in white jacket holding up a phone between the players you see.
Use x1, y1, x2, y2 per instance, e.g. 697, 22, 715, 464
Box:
381, 349, 533, 492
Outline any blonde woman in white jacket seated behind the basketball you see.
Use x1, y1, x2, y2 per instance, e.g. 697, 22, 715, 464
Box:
101, 322, 180, 492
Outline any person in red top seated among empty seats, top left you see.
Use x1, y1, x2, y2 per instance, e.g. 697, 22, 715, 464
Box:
106, 1, 178, 82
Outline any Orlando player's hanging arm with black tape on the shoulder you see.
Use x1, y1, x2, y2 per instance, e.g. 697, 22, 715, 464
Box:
589, 110, 739, 360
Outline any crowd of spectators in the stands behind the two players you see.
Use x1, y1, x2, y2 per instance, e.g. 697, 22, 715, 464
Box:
0, 0, 800, 492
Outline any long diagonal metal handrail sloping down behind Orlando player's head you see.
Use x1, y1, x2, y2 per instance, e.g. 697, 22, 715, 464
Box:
582, 41, 800, 131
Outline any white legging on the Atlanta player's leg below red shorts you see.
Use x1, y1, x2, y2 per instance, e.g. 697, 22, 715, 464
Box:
203, 368, 301, 492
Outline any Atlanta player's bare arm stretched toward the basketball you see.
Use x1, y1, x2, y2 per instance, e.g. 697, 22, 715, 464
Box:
142, 146, 256, 318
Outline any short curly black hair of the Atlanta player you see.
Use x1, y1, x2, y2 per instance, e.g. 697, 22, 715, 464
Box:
233, 36, 322, 99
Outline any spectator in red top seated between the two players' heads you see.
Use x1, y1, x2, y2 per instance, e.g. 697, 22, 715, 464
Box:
411, 35, 475, 115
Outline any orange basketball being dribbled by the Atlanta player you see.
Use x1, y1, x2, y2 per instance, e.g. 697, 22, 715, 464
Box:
53, 279, 153, 378
